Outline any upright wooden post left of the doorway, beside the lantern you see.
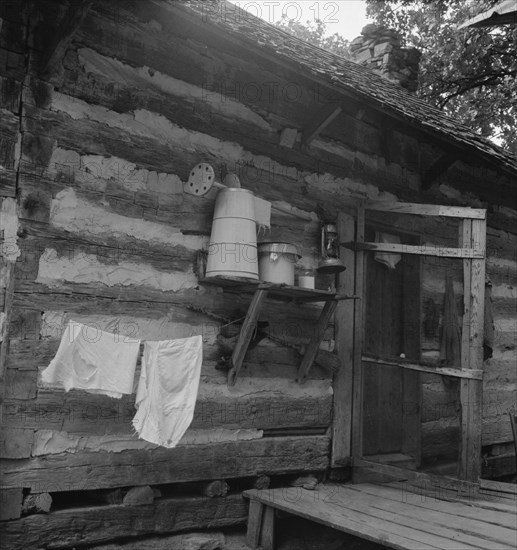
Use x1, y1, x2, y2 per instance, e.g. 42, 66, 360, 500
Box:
331, 213, 355, 468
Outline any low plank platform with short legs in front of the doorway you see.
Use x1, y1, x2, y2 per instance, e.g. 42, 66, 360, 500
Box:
244, 484, 517, 550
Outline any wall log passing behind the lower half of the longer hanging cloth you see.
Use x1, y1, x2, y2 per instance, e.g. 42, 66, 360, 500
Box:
2, 378, 332, 435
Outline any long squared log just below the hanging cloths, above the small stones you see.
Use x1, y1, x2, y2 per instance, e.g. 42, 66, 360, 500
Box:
0, 436, 329, 492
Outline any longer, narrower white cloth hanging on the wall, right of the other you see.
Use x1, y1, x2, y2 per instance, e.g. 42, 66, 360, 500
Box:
133, 336, 203, 448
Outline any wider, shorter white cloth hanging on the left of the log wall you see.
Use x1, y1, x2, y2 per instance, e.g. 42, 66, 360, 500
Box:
41, 321, 140, 399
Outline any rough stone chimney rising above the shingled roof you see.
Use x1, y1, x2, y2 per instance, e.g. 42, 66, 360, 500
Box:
350, 23, 422, 92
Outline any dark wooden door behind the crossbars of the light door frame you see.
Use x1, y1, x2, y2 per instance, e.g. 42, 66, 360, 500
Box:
362, 237, 420, 458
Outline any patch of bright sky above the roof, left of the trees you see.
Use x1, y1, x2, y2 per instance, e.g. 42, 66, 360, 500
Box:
230, 0, 369, 40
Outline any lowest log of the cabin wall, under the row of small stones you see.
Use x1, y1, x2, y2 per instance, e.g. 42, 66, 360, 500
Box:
0, 492, 248, 550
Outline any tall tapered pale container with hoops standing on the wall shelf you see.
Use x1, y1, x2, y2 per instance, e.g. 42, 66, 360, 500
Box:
206, 188, 258, 280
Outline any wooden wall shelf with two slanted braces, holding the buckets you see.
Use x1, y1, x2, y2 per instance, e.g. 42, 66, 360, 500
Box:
200, 277, 350, 386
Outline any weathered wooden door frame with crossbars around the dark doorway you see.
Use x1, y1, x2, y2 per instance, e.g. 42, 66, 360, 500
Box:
331, 201, 486, 483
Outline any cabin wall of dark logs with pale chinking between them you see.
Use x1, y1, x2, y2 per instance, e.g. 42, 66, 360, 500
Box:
0, 1, 517, 544
